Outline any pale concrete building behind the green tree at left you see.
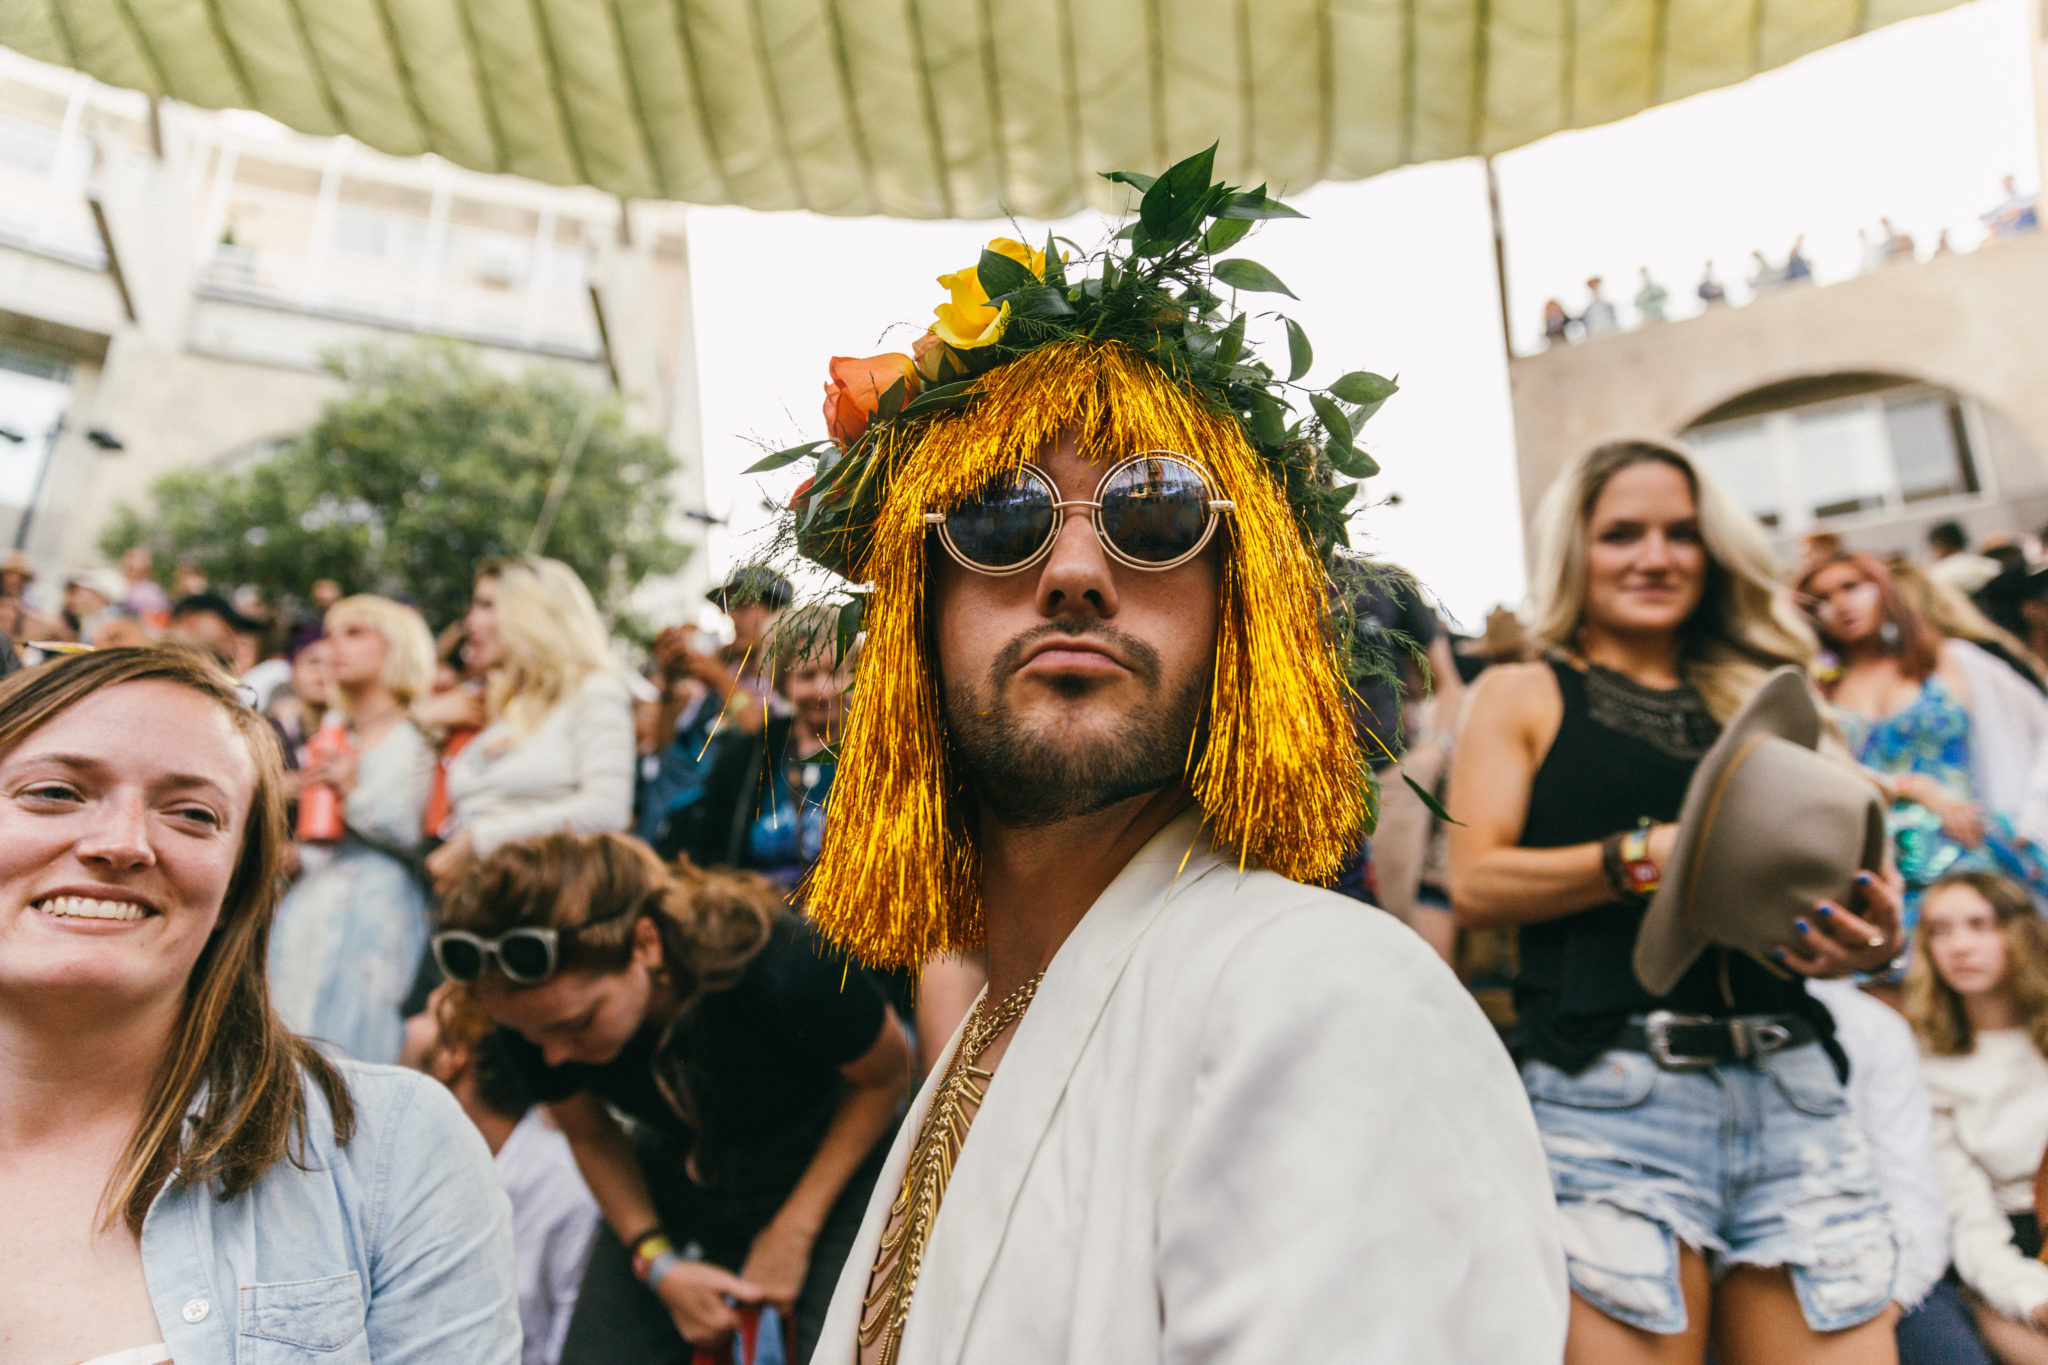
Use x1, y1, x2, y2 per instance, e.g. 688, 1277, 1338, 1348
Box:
0, 51, 709, 616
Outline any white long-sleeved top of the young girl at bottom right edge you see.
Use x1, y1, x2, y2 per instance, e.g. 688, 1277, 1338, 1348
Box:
1921, 1029, 2048, 1318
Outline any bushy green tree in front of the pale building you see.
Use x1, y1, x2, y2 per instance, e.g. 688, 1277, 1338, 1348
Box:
100, 342, 688, 624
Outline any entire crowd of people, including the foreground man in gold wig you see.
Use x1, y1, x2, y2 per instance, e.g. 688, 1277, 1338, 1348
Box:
19, 184, 2048, 1365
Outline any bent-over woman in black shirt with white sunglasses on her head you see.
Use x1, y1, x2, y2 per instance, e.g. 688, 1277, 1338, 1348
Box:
434, 833, 909, 1365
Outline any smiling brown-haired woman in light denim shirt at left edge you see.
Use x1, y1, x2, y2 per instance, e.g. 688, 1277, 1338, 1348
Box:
0, 649, 518, 1365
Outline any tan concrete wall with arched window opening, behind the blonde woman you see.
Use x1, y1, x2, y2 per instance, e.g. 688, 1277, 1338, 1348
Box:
1509, 233, 2048, 551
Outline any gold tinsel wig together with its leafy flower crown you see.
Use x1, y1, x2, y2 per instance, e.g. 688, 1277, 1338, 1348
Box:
754, 149, 1393, 968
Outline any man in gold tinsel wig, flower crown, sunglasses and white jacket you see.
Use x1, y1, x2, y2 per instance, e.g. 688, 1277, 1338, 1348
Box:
756, 149, 1567, 1365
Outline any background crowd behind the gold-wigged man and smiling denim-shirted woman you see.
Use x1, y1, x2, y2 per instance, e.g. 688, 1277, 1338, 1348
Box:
19, 444, 2048, 1365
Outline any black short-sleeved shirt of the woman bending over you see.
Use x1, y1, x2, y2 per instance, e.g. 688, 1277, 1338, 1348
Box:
498, 915, 885, 1193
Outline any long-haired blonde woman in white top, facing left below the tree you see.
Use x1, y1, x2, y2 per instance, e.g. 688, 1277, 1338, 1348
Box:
426, 555, 635, 898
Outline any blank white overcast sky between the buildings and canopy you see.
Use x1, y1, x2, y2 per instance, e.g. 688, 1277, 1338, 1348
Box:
690, 0, 2038, 628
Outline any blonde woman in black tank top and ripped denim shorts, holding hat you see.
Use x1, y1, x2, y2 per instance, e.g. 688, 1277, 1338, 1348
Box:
1450, 442, 1898, 1365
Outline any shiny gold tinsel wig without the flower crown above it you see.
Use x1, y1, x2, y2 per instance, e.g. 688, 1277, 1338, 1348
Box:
805, 342, 1366, 966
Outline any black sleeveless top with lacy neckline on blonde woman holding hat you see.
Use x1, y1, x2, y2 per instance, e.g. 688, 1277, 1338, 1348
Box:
1516, 659, 1835, 1070
